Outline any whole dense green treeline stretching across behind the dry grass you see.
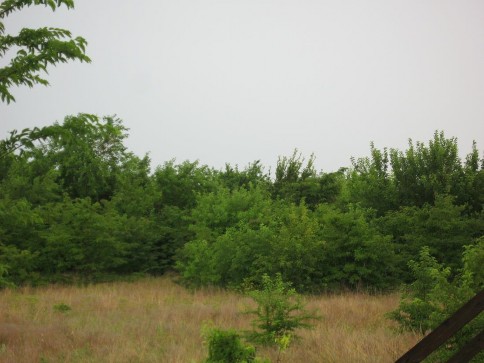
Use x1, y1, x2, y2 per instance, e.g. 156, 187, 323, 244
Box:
0, 114, 484, 292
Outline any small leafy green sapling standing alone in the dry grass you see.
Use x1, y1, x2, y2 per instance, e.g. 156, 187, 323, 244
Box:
245, 274, 319, 348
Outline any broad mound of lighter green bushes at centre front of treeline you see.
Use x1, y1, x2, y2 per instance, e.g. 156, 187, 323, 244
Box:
177, 196, 399, 292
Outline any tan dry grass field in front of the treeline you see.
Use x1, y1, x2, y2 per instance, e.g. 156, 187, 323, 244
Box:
0, 277, 420, 363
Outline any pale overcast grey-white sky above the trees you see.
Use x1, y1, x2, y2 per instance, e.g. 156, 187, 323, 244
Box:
0, 0, 484, 172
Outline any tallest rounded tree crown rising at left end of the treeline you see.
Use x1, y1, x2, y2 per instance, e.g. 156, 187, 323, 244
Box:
0, 114, 129, 201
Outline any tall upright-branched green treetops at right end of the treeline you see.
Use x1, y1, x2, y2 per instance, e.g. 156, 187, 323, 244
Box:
347, 131, 484, 216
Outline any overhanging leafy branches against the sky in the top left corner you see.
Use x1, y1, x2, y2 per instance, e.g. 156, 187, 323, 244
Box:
0, 0, 91, 103
